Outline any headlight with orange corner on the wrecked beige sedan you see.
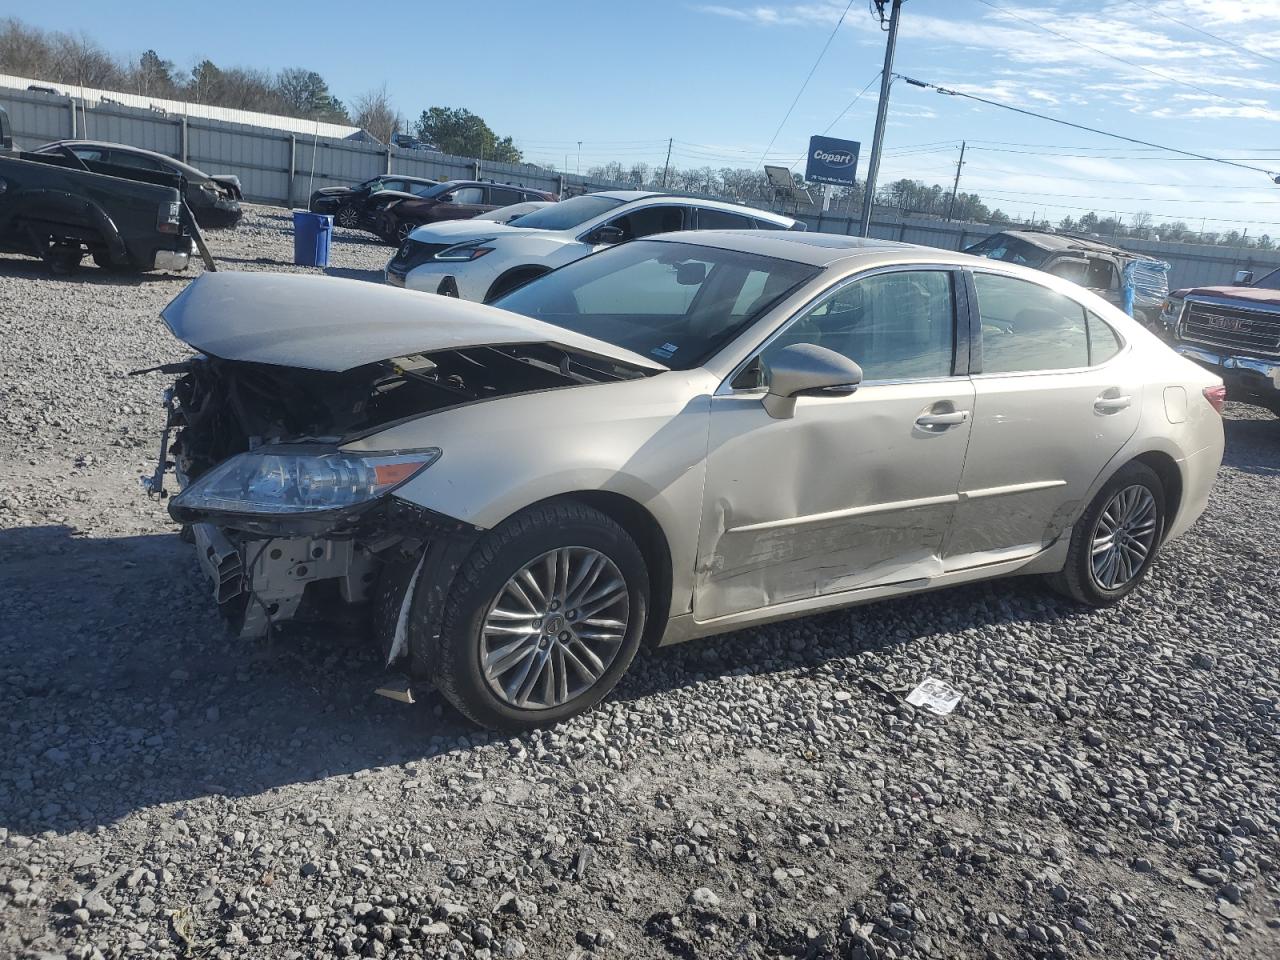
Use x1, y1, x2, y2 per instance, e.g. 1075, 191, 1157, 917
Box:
173, 447, 440, 515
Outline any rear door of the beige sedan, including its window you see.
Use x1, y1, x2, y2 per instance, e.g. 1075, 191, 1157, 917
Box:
945, 270, 1143, 571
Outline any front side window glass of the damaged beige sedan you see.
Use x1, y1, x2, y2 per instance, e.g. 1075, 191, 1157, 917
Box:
762, 270, 955, 380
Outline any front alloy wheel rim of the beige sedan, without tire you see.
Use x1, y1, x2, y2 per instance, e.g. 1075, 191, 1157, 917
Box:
480, 547, 630, 710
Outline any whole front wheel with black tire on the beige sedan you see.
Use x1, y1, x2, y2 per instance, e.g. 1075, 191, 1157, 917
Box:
411, 500, 649, 731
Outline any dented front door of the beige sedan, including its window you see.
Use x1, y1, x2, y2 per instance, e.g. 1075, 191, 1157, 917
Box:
694, 268, 973, 621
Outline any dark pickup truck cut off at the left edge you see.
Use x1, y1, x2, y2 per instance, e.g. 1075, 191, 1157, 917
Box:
0, 109, 204, 273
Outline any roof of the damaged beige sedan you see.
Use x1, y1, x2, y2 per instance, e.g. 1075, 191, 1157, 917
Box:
645, 230, 983, 266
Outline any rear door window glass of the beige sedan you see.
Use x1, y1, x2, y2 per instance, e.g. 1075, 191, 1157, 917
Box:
973, 273, 1089, 374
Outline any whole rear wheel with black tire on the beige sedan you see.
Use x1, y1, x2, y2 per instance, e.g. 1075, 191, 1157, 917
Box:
1048, 462, 1165, 607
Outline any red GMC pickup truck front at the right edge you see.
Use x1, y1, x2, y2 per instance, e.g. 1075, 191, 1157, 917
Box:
1161, 269, 1280, 416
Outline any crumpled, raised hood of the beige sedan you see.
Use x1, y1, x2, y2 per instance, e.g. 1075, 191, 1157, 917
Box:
161, 273, 667, 371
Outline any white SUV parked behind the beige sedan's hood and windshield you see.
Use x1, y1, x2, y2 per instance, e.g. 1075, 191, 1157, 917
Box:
387, 189, 805, 302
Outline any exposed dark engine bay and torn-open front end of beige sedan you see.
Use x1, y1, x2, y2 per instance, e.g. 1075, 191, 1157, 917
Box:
160, 343, 644, 642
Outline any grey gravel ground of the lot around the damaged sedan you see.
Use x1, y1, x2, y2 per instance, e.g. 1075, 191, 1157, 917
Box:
0, 207, 1280, 960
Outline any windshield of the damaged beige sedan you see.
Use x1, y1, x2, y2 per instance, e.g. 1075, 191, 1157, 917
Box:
495, 240, 818, 370
